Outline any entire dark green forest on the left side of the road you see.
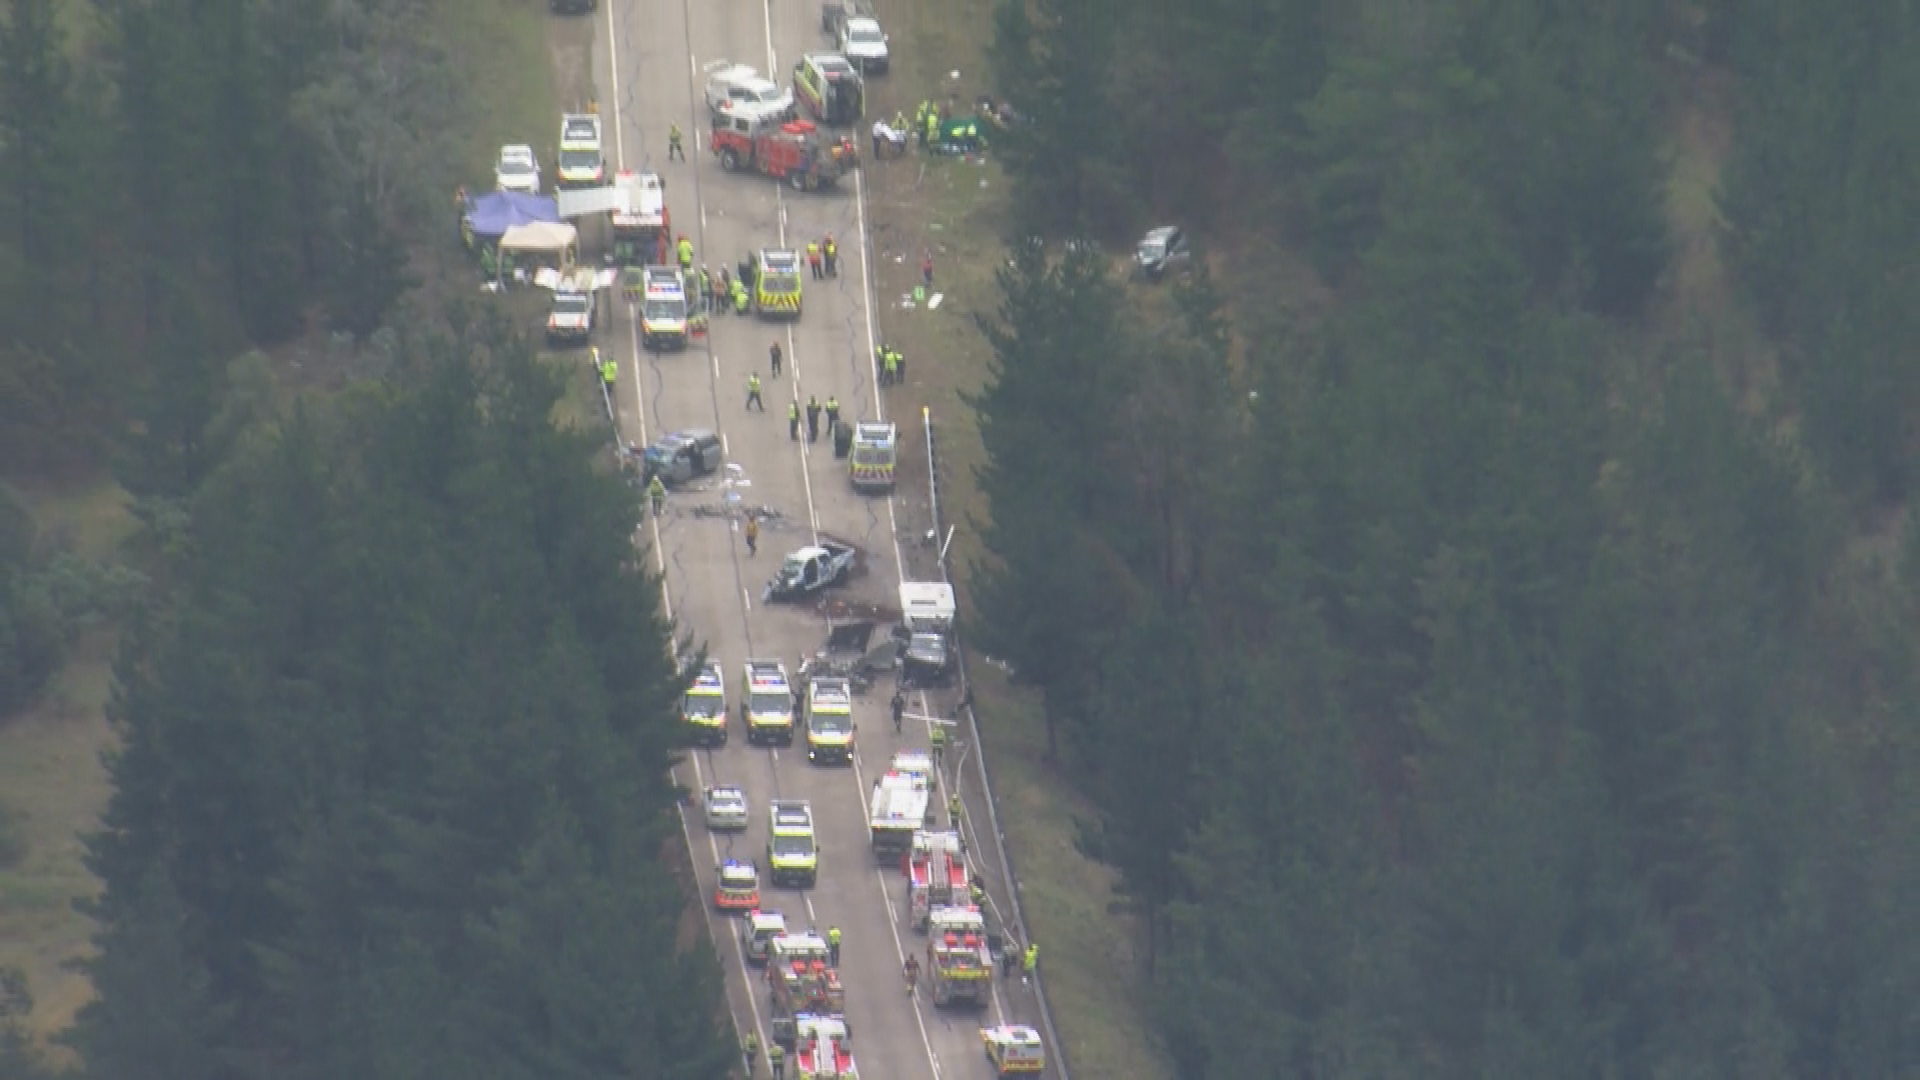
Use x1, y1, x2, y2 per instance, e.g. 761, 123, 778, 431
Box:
0, 0, 737, 1080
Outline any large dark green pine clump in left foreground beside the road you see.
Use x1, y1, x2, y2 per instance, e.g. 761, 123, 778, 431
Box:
75, 315, 733, 1078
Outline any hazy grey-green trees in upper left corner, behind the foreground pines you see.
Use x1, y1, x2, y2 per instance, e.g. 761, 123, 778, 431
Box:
0, 0, 476, 474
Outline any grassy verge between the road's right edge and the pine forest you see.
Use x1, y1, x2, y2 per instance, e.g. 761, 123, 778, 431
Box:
868, 0, 1171, 1080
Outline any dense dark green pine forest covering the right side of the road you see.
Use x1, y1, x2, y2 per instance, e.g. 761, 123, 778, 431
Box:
973, 0, 1920, 1080
